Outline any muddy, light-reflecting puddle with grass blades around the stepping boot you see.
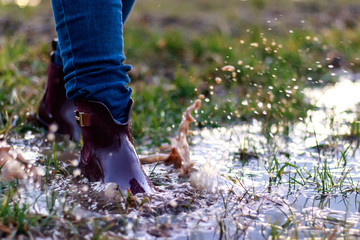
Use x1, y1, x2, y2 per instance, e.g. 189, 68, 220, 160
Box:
9, 74, 360, 239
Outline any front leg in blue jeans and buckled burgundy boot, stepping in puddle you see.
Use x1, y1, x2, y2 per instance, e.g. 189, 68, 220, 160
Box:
52, 0, 154, 194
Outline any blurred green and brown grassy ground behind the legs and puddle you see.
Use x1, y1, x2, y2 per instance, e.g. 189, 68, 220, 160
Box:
0, 0, 360, 145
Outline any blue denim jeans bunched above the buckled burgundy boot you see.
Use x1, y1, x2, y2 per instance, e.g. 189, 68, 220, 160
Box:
51, 0, 135, 122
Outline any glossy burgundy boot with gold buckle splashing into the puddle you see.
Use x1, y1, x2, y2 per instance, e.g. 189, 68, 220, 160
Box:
75, 99, 155, 195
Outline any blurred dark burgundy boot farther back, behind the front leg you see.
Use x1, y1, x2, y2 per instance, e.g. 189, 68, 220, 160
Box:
36, 41, 80, 142
